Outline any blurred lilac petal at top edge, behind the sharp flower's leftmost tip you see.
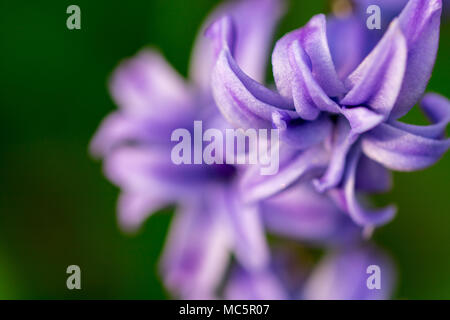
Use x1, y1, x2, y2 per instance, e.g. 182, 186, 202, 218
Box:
189, 0, 284, 91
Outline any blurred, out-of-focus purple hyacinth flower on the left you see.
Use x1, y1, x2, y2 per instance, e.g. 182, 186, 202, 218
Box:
91, 0, 282, 298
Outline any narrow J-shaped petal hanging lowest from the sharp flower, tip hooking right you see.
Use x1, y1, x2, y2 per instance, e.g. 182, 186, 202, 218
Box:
342, 146, 396, 227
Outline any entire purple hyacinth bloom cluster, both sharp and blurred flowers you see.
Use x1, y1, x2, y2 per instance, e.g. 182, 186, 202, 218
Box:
91, 0, 450, 299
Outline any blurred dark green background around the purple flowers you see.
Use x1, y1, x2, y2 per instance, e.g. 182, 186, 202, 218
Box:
0, 0, 450, 299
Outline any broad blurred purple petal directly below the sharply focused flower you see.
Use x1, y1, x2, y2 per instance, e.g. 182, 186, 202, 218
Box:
260, 184, 360, 244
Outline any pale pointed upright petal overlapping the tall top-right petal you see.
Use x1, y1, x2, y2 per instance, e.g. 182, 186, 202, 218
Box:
340, 20, 407, 117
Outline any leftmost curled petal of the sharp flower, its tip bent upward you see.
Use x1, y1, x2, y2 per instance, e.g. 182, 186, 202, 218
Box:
209, 17, 297, 128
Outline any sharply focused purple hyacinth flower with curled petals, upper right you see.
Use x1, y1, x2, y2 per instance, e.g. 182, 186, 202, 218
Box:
209, 0, 450, 227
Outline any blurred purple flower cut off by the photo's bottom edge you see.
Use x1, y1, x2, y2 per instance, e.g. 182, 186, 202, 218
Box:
224, 243, 395, 300
